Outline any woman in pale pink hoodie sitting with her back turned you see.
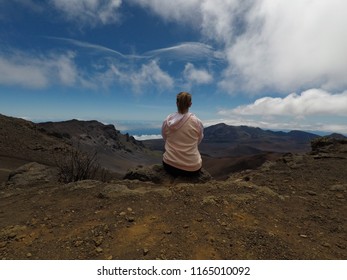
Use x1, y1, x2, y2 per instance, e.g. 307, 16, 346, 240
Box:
162, 92, 204, 176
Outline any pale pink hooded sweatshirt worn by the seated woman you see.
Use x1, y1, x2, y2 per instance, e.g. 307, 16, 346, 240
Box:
162, 113, 204, 171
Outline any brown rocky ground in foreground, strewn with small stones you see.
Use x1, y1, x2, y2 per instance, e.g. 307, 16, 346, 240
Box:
0, 138, 347, 259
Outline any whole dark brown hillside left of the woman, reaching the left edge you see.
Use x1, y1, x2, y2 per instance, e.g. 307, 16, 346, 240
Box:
0, 115, 160, 177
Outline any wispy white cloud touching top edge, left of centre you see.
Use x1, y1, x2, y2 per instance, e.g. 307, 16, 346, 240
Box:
50, 0, 122, 27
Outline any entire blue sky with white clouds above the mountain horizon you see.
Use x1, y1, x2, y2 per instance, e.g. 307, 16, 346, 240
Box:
0, 0, 347, 135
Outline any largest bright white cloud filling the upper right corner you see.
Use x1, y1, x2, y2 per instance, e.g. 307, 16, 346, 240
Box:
221, 0, 347, 92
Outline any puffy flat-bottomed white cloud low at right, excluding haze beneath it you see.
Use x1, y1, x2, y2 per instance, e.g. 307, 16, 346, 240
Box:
220, 89, 347, 117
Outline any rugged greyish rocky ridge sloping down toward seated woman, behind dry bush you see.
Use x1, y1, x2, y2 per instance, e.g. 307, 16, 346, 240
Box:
37, 120, 160, 174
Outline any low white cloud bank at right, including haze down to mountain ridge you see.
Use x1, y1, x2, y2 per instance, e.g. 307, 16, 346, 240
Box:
215, 89, 347, 134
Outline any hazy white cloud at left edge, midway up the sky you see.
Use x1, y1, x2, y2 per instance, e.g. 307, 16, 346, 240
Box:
0, 52, 79, 89
